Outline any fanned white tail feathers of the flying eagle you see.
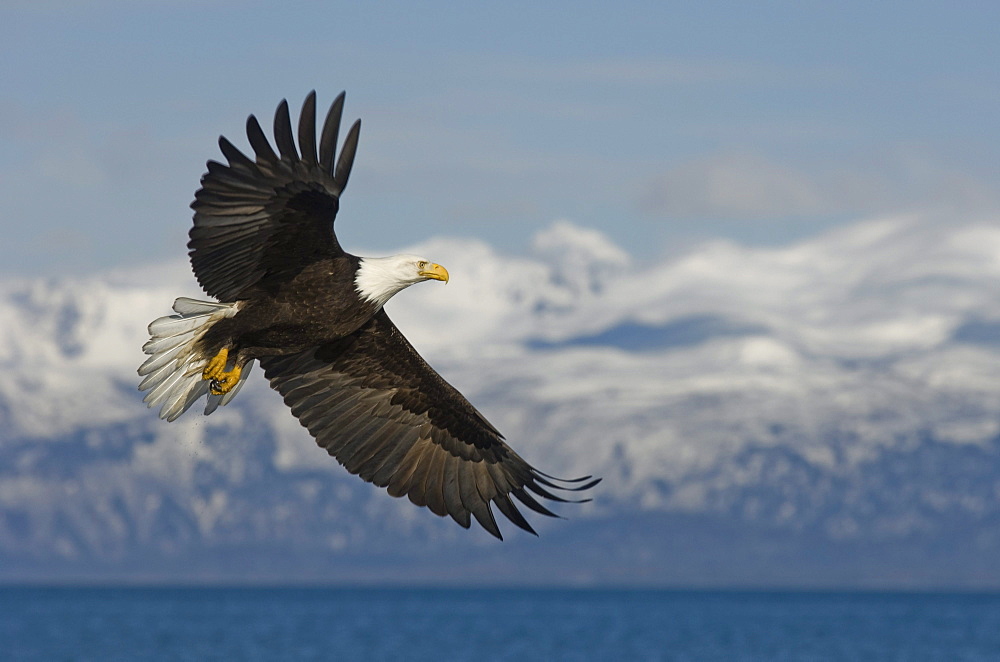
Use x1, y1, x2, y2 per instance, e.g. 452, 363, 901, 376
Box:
139, 297, 253, 421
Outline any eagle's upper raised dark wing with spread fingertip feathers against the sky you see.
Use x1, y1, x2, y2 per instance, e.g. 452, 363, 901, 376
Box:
188, 92, 361, 301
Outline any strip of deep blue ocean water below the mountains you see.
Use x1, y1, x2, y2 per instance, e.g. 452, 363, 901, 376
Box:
0, 587, 1000, 662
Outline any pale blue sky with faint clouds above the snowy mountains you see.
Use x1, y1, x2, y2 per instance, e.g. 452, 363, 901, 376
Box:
0, 0, 1000, 276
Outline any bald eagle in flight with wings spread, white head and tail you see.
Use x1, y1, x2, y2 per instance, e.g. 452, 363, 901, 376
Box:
138, 92, 600, 538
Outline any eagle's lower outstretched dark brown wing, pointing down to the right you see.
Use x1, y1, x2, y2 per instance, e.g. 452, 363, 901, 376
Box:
260, 311, 599, 538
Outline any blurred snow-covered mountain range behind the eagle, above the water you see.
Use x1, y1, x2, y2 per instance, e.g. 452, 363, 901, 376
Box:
0, 217, 1000, 586
